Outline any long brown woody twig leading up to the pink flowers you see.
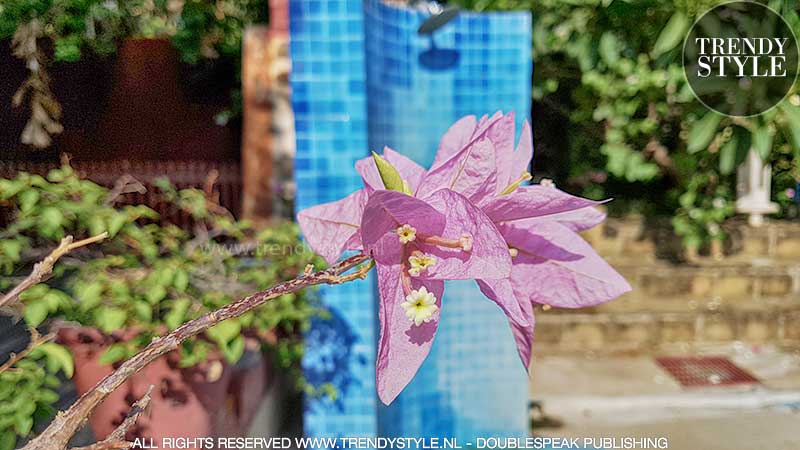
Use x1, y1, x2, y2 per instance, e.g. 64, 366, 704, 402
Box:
22, 254, 370, 450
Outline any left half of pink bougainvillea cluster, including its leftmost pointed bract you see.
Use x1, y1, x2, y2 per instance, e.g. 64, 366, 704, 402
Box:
298, 148, 512, 404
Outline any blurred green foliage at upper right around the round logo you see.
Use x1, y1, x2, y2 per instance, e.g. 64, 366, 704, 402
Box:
457, 0, 800, 248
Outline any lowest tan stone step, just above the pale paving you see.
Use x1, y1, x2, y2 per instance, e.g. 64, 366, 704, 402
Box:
534, 296, 800, 353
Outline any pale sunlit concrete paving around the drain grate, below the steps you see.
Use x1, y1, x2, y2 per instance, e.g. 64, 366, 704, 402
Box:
530, 343, 800, 450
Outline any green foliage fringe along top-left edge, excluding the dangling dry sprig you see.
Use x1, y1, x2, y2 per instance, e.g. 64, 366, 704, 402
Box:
0, 0, 269, 63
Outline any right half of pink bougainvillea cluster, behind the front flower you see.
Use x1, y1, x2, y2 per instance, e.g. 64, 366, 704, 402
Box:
419, 112, 631, 367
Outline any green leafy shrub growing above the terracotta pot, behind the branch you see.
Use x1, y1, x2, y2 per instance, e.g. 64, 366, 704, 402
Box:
0, 166, 322, 446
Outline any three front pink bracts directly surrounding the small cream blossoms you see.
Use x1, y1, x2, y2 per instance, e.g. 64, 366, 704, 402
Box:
361, 189, 512, 404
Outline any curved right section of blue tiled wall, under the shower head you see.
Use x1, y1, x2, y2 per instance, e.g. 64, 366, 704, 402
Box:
364, 0, 531, 439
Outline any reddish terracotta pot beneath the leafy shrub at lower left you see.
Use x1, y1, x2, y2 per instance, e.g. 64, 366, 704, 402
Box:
58, 327, 267, 443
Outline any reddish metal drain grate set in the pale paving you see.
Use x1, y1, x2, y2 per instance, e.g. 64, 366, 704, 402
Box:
656, 356, 760, 387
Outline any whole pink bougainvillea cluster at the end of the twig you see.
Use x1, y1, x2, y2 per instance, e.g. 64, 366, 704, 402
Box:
298, 112, 630, 404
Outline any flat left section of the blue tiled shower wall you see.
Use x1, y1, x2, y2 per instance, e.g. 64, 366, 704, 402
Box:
289, 0, 377, 437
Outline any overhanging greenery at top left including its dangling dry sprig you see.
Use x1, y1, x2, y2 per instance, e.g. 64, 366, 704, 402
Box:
0, 0, 269, 148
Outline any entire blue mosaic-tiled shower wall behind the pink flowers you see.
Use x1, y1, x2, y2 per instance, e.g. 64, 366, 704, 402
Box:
290, 0, 531, 439
